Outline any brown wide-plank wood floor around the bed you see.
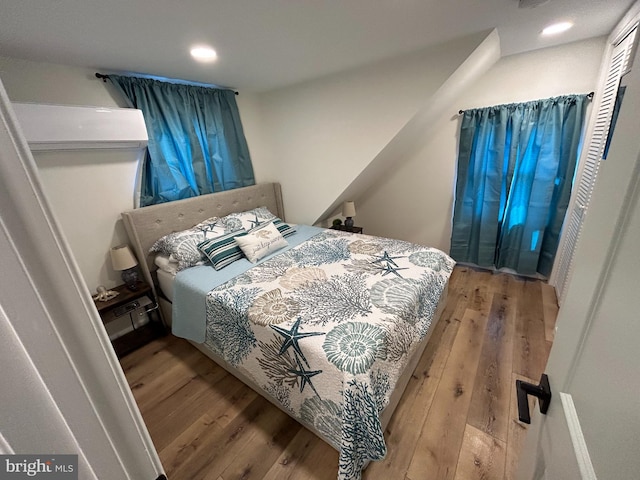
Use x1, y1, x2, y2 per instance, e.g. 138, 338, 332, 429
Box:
121, 267, 557, 480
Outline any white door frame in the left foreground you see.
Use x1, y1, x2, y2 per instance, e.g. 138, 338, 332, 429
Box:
0, 81, 163, 480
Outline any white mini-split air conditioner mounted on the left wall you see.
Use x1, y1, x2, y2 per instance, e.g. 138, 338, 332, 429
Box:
13, 103, 148, 150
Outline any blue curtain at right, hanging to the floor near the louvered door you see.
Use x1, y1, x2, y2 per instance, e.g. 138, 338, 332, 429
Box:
450, 95, 587, 277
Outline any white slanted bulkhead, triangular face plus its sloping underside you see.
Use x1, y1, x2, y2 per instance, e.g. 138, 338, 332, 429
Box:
252, 30, 500, 224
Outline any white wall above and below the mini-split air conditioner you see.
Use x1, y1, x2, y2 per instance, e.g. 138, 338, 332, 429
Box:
0, 57, 137, 292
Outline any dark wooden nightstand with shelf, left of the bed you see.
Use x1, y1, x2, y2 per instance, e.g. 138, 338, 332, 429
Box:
94, 281, 167, 358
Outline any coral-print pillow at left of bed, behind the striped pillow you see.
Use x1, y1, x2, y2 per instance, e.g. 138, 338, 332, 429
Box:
149, 217, 225, 270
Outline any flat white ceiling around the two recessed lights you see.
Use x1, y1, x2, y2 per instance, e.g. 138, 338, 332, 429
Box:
0, 0, 634, 91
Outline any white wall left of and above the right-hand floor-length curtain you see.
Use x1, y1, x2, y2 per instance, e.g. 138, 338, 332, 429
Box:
354, 37, 605, 252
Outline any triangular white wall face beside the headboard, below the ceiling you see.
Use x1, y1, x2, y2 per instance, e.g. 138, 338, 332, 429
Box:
258, 32, 487, 223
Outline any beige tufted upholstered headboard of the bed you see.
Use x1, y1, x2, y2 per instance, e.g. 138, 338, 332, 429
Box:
122, 183, 285, 296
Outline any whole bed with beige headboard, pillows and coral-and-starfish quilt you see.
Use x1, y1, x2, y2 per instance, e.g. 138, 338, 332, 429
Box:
122, 183, 454, 480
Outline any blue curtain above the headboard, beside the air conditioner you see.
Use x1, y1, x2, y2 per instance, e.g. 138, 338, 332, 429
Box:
108, 75, 255, 206
